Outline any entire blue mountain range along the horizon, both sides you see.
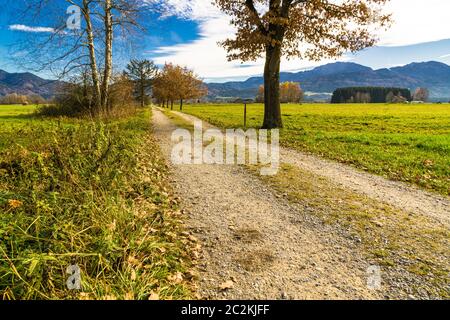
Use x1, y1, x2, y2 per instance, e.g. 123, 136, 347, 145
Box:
0, 61, 450, 101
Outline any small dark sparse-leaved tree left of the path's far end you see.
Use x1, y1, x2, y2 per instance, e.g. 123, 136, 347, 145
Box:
125, 59, 158, 107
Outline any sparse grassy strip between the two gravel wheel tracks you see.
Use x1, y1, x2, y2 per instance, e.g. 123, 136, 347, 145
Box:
256, 164, 450, 299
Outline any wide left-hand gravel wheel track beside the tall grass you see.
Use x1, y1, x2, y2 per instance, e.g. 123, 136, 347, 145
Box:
153, 109, 391, 299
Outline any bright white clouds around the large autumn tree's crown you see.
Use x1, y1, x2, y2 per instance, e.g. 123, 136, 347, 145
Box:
149, 0, 450, 81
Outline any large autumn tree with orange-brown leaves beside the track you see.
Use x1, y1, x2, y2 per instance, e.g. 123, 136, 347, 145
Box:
215, 0, 390, 128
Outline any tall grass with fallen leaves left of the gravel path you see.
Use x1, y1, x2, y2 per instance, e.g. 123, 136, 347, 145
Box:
0, 106, 191, 300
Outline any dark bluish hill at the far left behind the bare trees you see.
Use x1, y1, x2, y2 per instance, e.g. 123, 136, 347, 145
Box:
0, 70, 62, 98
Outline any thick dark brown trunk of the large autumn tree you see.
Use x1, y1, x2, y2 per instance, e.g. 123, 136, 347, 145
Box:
263, 45, 283, 129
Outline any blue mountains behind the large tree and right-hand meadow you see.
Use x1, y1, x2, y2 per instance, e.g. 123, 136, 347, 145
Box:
208, 61, 450, 101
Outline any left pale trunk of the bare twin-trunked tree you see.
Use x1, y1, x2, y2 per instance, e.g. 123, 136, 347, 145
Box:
83, 0, 101, 113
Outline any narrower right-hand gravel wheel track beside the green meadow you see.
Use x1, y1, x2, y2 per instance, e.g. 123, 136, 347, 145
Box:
175, 112, 450, 227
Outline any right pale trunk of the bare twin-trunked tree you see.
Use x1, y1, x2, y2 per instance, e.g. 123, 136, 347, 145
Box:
102, 0, 113, 110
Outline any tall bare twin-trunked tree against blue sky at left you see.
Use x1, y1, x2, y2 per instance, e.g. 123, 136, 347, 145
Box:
8, 0, 150, 113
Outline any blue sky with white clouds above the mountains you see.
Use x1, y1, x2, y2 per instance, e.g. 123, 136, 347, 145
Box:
0, 0, 450, 82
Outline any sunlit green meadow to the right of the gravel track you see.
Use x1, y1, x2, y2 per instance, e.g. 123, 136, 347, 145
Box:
183, 104, 450, 195
